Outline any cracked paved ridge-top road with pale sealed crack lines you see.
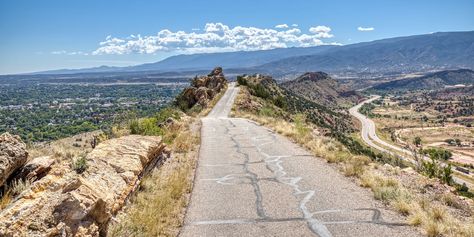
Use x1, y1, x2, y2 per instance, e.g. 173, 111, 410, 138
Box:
180, 85, 418, 237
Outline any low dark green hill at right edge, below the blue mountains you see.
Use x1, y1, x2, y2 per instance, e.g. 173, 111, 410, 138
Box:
372, 69, 474, 91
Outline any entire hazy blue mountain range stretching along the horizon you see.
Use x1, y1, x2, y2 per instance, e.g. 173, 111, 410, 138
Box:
29, 31, 474, 75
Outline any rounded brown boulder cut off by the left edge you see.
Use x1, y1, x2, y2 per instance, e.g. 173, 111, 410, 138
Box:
0, 133, 28, 186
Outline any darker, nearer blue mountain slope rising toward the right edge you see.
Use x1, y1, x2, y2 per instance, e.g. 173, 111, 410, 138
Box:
260, 31, 474, 73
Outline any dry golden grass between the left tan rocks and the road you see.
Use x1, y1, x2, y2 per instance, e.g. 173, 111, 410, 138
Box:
109, 117, 199, 236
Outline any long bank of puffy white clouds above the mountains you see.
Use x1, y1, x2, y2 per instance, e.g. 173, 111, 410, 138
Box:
92, 23, 337, 55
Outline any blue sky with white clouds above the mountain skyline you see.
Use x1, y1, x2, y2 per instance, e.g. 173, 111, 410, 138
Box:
0, 0, 474, 74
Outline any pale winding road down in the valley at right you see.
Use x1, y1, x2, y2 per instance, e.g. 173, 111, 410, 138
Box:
349, 95, 474, 188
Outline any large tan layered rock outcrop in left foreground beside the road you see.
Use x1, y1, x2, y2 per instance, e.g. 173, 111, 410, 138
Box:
0, 135, 167, 236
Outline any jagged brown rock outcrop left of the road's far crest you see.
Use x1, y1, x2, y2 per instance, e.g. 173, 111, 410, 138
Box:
177, 67, 227, 109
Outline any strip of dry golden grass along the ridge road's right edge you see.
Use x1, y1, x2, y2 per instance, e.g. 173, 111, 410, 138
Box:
233, 86, 474, 237
